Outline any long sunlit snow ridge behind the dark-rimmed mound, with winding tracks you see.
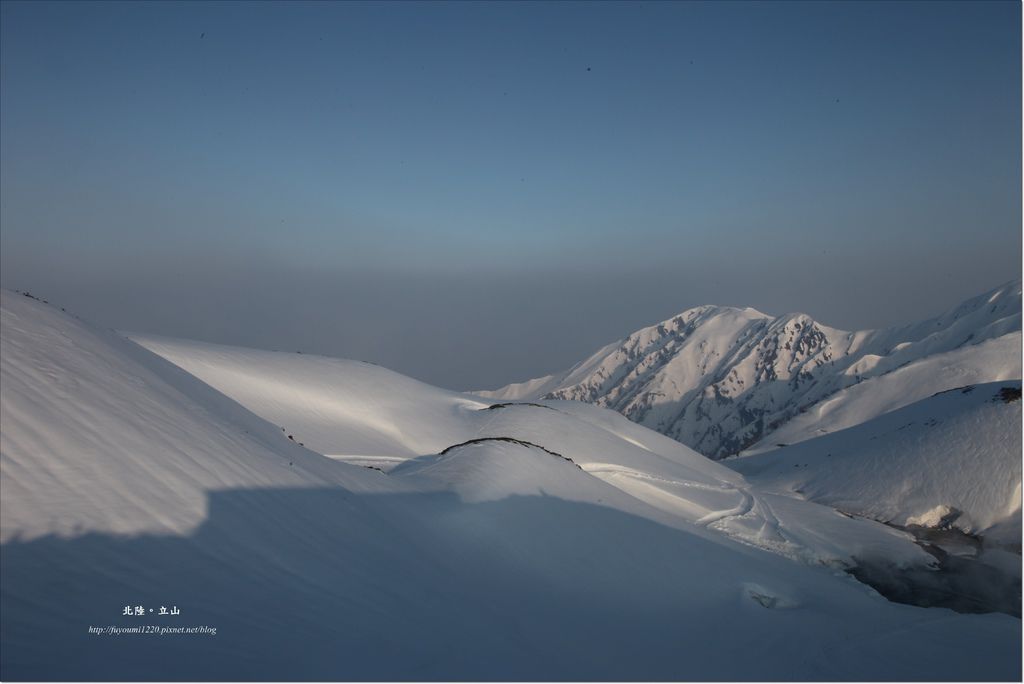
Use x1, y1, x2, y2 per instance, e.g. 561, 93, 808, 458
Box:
133, 335, 930, 566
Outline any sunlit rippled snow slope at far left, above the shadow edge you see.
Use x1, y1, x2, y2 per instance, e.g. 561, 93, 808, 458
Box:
0, 291, 372, 543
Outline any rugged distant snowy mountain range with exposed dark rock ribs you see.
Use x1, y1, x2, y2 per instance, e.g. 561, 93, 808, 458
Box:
476, 281, 1021, 458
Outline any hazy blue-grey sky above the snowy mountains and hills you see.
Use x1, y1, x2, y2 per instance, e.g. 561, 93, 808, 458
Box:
0, 1, 1021, 389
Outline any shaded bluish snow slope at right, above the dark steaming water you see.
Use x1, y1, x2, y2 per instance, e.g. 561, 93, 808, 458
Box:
724, 381, 1021, 544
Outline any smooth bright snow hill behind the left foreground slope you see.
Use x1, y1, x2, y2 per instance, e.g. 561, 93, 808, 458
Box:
131, 335, 490, 459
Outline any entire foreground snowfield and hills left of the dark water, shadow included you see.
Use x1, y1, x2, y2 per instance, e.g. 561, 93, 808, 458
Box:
0, 292, 1021, 680
